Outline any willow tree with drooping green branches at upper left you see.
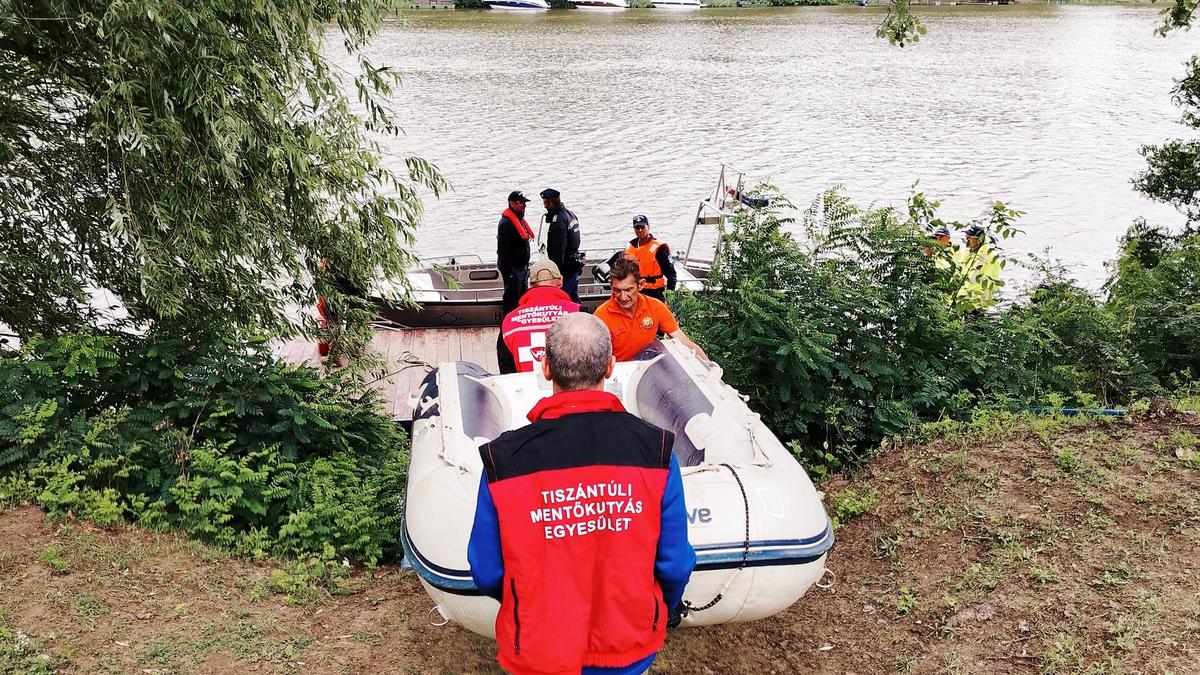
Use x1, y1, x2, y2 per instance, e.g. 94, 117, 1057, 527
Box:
0, 0, 445, 353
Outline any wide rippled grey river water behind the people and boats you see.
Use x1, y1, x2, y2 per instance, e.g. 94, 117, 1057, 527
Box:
338, 6, 1200, 287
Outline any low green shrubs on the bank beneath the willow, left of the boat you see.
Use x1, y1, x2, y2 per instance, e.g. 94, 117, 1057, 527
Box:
0, 334, 407, 565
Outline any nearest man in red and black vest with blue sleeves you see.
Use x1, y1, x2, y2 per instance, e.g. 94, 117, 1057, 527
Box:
467, 312, 696, 675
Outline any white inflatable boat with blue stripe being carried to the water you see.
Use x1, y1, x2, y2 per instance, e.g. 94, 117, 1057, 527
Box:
402, 340, 834, 637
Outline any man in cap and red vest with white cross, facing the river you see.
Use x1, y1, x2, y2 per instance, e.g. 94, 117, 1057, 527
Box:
499, 261, 580, 372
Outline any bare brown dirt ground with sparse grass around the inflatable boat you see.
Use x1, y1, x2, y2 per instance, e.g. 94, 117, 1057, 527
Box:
0, 418, 1200, 674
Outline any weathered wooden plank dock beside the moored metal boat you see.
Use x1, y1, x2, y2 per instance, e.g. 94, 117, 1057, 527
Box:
275, 328, 499, 422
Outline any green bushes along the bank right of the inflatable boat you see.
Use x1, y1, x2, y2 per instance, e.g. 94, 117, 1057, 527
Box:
678, 186, 1200, 470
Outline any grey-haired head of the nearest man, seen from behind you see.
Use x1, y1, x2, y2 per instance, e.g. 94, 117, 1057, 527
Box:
546, 312, 612, 392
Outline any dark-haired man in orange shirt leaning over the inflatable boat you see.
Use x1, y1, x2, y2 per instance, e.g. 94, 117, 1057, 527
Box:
595, 258, 708, 362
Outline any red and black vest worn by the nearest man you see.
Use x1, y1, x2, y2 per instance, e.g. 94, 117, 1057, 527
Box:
479, 392, 674, 674
